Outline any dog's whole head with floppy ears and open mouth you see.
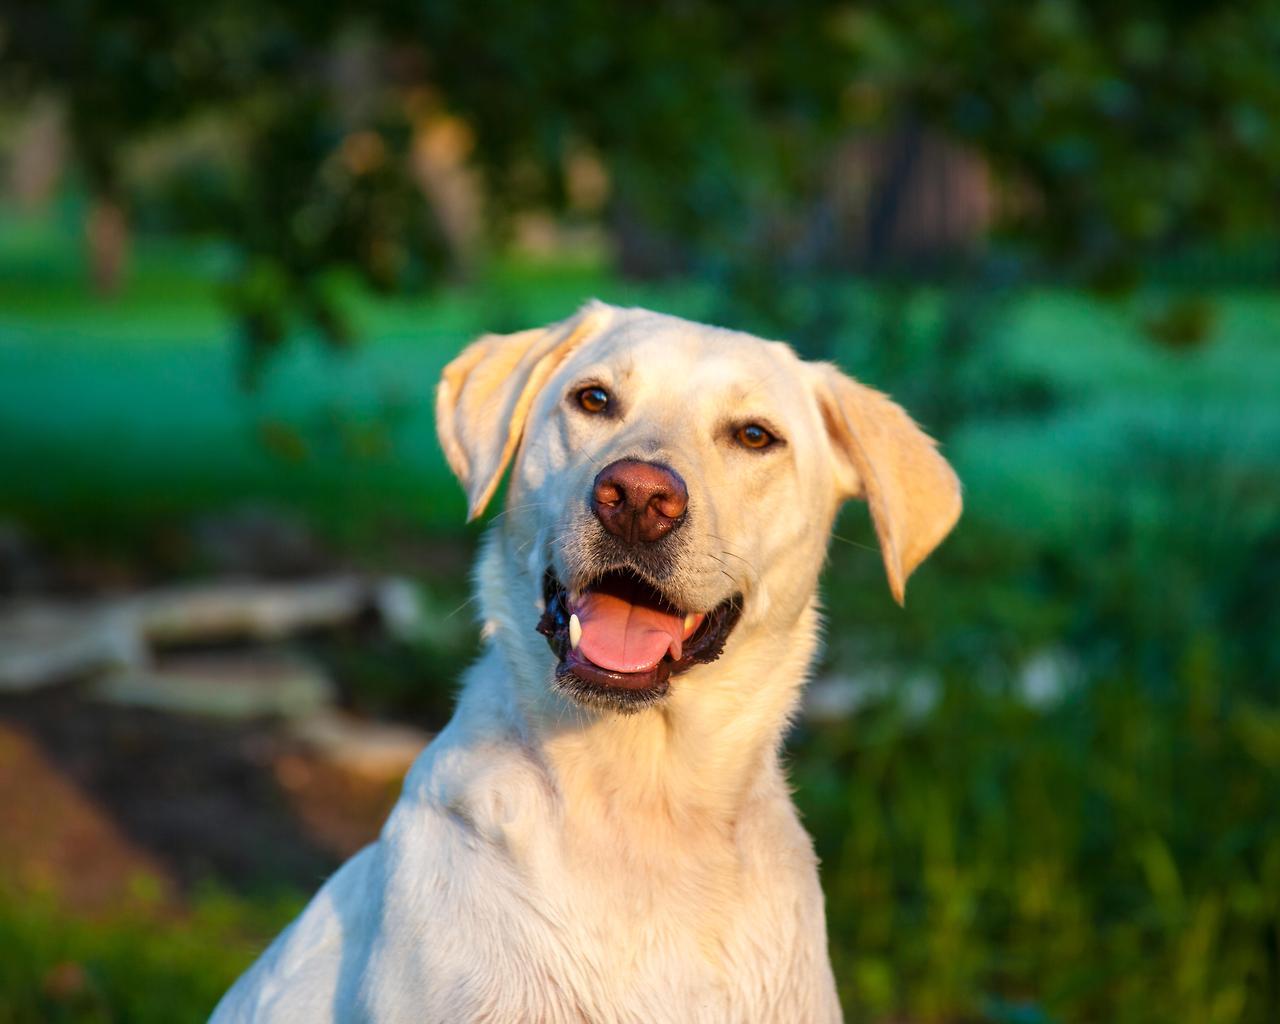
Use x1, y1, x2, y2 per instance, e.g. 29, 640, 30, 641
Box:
436, 303, 960, 710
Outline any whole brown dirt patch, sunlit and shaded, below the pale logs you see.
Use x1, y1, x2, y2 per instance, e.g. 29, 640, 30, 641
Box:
0, 687, 399, 909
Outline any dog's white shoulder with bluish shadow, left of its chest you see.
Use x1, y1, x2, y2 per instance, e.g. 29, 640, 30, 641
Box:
212, 658, 560, 1024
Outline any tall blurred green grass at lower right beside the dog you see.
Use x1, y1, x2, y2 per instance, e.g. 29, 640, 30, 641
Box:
794, 665, 1280, 1024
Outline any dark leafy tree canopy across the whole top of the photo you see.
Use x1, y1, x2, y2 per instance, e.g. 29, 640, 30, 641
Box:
0, 0, 1280, 367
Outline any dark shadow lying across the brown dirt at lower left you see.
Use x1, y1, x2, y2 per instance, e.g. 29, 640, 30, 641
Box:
0, 687, 350, 888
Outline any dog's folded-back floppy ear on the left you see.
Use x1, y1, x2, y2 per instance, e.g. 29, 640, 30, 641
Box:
435, 302, 611, 522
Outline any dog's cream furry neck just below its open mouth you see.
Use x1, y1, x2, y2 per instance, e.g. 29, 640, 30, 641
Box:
477, 536, 819, 838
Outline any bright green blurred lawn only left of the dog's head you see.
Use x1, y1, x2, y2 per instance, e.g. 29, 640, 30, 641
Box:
0, 206, 721, 545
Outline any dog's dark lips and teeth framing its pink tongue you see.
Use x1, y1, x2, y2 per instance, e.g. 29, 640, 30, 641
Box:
536, 568, 742, 714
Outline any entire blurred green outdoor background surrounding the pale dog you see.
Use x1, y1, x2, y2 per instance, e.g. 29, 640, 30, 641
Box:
0, 0, 1280, 1024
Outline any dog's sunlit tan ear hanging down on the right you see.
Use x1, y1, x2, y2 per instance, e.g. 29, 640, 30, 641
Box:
814, 364, 960, 604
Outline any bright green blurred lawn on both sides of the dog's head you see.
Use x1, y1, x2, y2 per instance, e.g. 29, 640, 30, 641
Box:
0, 209, 1280, 568
